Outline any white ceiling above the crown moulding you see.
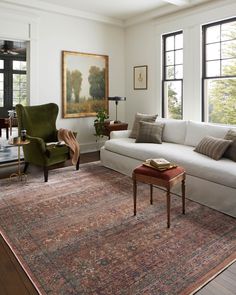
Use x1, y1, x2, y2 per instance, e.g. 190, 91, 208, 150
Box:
0, 0, 214, 26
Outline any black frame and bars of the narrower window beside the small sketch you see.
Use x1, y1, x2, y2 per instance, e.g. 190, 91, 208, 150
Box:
162, 30, 184, 119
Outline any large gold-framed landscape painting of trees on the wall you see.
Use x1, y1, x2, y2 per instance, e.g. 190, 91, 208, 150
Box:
62, 51, 108, 118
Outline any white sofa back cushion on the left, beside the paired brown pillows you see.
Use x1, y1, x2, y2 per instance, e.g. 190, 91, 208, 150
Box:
156, 118, 187, 144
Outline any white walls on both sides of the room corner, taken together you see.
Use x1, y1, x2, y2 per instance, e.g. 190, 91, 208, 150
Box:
0, 0, 236, 152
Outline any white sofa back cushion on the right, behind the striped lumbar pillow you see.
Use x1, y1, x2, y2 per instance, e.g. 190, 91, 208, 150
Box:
184, 121, 229, 146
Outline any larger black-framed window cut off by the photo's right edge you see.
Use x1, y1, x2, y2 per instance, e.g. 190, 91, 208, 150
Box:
202, 18, 236, 124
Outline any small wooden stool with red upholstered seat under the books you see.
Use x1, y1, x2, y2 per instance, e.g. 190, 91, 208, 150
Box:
132, 165, 185, 228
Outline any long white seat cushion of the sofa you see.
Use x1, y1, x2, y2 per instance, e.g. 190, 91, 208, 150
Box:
105, 138, 236, 188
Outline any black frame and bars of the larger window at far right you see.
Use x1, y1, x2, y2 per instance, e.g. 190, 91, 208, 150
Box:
202, 17, 236, 122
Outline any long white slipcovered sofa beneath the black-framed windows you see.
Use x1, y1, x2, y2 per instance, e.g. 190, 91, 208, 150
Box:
100, 119, 236, 217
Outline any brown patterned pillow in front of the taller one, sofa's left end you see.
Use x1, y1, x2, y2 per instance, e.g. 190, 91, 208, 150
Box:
135, 121, 164, 143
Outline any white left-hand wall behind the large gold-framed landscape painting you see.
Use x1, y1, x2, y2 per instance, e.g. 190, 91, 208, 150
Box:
0, 5, 125, 152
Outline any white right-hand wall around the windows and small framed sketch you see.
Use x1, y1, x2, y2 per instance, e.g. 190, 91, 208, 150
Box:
126, 1, 236, 124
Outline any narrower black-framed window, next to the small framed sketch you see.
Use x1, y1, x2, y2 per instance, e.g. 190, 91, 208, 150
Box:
162, 31, 183, 119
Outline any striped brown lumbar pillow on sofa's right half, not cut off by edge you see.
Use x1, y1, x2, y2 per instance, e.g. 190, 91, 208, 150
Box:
194, 136, 232, 160
